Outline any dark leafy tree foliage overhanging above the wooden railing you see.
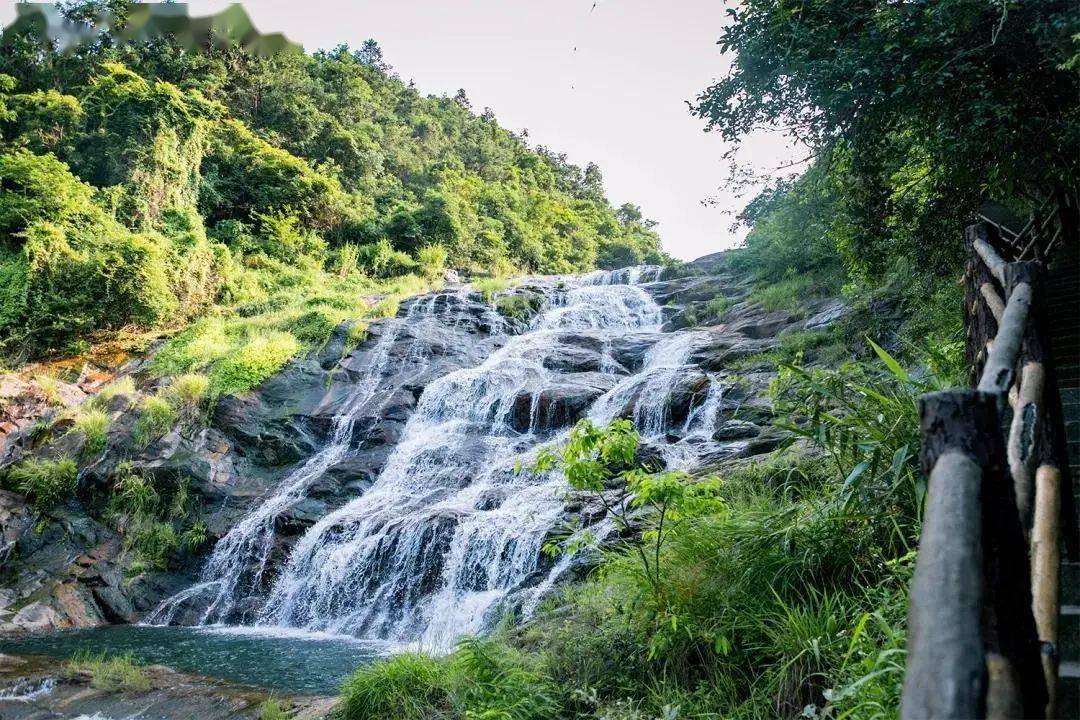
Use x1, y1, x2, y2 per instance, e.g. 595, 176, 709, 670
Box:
696, 0, 1080, 293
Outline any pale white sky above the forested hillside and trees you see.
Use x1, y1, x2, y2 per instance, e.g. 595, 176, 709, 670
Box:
0, 0, 789, 259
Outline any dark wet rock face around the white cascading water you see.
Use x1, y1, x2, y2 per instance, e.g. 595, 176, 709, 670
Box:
0, 262, 833, 633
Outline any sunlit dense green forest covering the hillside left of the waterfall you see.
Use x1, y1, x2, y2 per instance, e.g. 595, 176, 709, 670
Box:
0, 2, 662, 357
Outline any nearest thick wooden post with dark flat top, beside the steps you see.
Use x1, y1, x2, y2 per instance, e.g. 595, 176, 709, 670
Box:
901, 391, 998, 720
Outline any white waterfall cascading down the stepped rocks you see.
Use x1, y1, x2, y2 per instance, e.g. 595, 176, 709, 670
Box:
149, 268, 738, 649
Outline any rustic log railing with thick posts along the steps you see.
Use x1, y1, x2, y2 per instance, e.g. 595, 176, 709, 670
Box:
901, 198, 1076, 720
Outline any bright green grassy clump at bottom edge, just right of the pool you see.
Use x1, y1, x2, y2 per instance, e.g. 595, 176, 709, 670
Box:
341, 653, 457, 720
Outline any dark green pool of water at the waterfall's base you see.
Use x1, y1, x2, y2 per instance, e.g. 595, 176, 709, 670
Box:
0, 625, 387, 694
